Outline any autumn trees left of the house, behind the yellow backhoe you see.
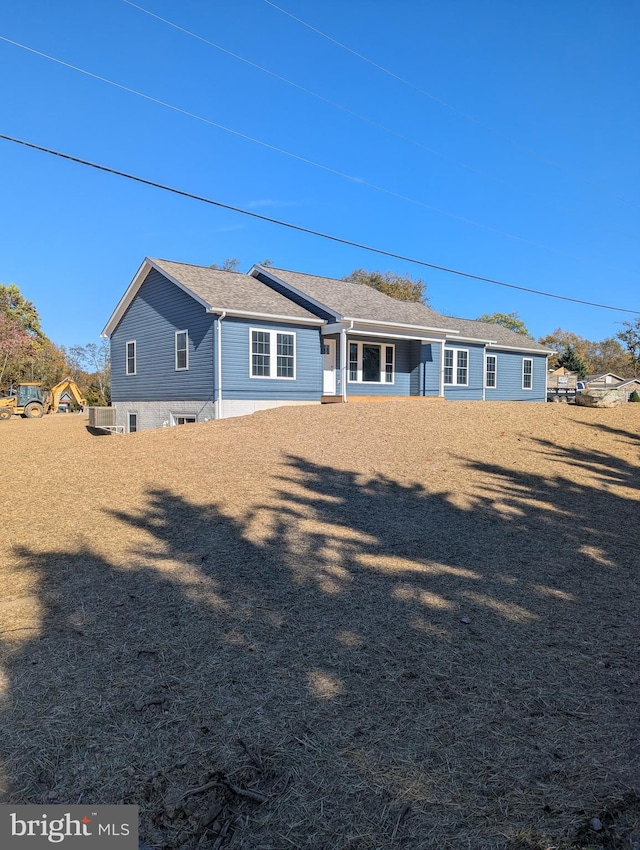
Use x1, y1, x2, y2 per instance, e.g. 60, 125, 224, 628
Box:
0, 283, 109, 405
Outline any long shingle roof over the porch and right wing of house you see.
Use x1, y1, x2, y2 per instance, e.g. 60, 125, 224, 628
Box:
249, 265, 551, 354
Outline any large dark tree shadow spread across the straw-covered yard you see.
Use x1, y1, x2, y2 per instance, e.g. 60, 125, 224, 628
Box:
0, 444, 640, 850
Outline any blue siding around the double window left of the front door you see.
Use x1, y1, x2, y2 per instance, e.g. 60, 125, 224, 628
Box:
221, 317, 322, 401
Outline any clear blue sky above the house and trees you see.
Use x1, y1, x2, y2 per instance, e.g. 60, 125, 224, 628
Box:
0, 0, 640, 345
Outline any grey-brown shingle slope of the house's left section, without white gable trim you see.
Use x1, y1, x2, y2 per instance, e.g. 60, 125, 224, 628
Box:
151, 259, 317, 319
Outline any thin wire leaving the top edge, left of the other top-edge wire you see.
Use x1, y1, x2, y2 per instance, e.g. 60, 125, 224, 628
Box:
122, 0, 575, 215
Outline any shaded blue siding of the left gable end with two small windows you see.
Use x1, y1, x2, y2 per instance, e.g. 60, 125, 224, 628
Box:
111, 270, 214, 402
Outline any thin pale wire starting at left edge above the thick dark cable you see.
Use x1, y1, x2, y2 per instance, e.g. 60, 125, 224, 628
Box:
0, 35, 626, 273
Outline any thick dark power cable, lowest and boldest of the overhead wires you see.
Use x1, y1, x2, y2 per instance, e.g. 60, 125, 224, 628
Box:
0, 133, 640, 315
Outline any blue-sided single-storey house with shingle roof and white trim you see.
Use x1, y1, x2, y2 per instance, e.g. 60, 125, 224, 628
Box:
103, 259, 551, 431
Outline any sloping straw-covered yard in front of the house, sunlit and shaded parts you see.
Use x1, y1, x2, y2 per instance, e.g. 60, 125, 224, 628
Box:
0, 400, 640, 850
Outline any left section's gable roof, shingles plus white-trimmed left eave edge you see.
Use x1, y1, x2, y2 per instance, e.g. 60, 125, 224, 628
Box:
102, 257, 323, 336
